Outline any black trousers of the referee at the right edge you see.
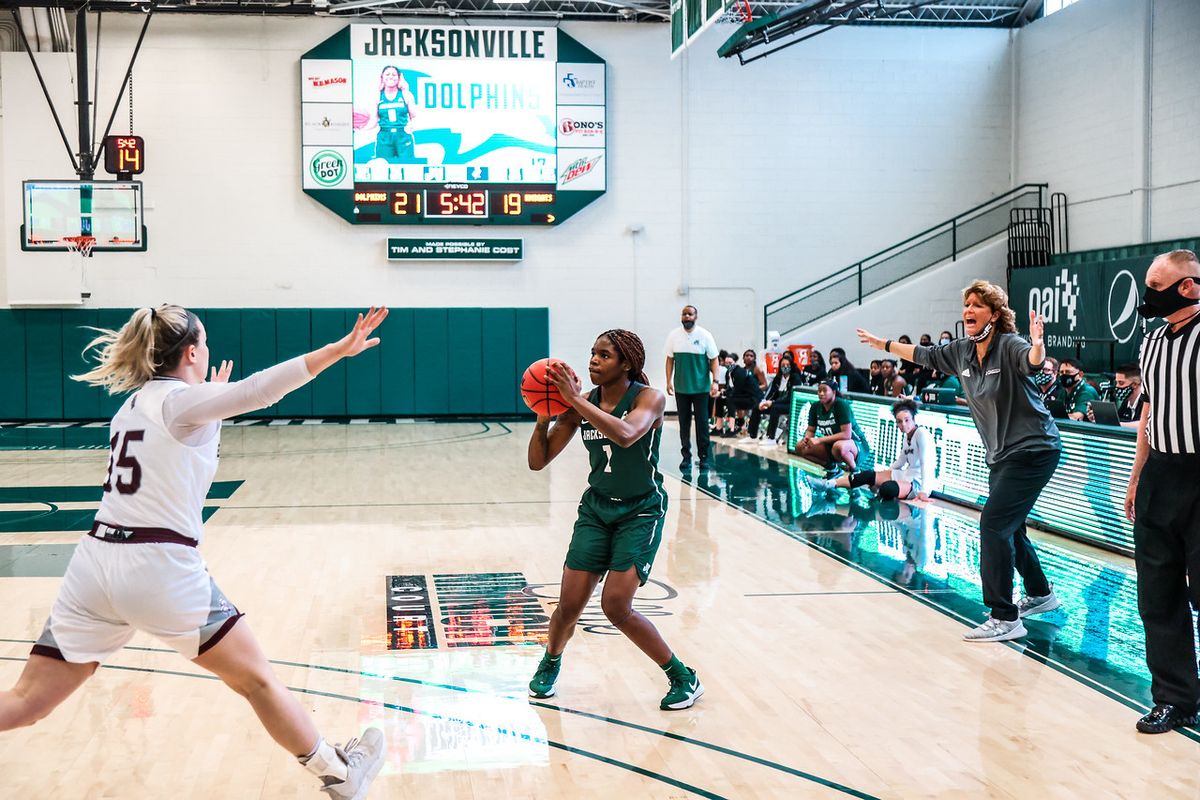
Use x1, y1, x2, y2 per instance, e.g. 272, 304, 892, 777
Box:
1133, 451, 1200, 712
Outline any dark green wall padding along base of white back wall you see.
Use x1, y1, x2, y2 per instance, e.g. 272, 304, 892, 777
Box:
0, 308, 550, 421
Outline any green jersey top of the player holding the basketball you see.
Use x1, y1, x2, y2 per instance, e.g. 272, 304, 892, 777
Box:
580, 383, 662, 500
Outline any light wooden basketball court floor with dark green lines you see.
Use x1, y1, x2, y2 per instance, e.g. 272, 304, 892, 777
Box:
0, 422, 1200, 800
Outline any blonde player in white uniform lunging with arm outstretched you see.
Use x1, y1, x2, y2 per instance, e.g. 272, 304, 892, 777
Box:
0, 305, 388, 800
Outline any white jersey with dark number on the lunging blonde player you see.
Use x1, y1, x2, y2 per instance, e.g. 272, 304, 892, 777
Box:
96, 378, 221, 543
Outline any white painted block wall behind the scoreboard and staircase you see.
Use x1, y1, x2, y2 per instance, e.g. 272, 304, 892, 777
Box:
0, 0, 1200, 393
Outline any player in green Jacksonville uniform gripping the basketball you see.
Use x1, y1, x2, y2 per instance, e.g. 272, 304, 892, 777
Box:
529, 330, 704, 710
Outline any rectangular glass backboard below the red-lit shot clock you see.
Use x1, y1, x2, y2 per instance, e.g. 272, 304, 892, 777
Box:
20, 180, 146, 252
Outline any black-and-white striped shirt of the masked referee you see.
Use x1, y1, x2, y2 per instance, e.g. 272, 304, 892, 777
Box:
1140, 309, 1200, 455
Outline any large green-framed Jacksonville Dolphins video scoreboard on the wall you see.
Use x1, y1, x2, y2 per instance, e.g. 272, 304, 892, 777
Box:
300, 24, 607, 224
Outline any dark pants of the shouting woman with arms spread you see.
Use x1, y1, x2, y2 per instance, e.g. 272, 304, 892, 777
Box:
979, 450, 1061, 621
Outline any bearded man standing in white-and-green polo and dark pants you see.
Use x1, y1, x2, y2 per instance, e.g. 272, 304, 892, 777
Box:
666, 306, 719, 470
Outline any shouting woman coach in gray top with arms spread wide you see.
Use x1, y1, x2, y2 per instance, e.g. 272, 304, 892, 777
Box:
858, 281, 1062, 642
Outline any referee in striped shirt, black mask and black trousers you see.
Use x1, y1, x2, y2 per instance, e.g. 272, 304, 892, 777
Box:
1124, 249, 1200, 733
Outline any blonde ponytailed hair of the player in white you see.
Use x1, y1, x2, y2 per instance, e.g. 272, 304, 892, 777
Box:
71, 305, 200, 395
